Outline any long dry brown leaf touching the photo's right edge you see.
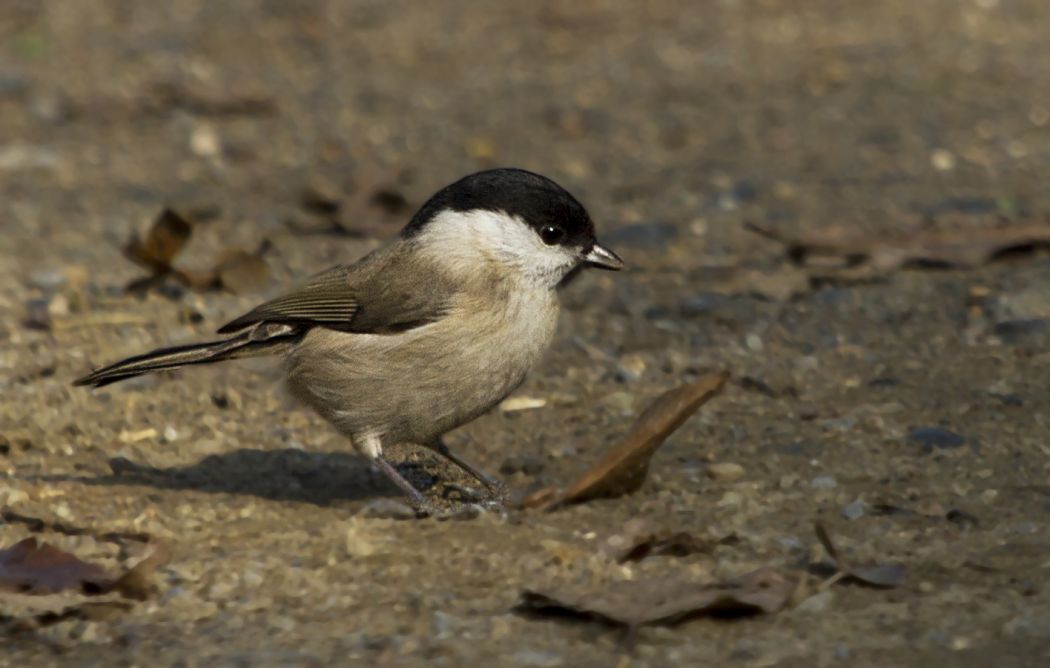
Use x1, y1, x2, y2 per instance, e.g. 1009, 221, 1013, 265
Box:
748, 223, 1050, 272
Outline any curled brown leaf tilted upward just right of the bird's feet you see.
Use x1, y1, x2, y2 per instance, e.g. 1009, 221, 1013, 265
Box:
522, 372, 730, 510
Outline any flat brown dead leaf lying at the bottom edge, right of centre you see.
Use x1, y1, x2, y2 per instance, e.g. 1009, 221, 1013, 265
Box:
518, 566, 801, 628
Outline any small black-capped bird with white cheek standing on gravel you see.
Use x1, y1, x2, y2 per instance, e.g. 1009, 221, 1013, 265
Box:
74, 168, 624, 515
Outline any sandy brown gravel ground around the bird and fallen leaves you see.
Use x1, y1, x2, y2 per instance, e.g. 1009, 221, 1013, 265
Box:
0, 0, 1050, 666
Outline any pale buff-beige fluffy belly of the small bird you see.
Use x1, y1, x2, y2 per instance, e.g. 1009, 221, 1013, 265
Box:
279, 291, 557, 444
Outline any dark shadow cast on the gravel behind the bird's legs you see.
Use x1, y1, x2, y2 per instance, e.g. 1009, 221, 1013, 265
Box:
34, 448, 438, 505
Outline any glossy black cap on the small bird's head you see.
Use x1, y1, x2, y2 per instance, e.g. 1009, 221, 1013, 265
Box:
401, 167, 594, 248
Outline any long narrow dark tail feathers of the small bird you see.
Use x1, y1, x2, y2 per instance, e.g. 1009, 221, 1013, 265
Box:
72, 331, 289, 388
